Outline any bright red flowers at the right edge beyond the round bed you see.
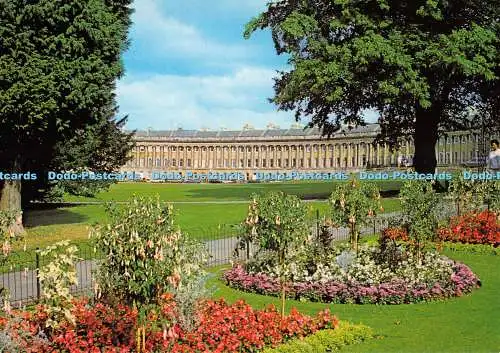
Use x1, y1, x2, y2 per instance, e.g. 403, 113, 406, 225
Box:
438, 211, 500, 245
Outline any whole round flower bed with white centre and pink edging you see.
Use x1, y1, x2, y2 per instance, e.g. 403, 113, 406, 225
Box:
223, 245, 480, 304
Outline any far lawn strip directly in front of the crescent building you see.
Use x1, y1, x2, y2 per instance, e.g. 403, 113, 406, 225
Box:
64, 181, 401, 202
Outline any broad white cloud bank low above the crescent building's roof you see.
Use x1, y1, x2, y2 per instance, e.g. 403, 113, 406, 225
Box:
117, 67, 294, 130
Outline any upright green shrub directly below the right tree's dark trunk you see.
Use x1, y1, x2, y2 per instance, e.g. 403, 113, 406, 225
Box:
400, 180, 438, 257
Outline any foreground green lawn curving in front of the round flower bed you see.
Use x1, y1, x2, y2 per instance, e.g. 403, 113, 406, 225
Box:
211, 252, 500, 353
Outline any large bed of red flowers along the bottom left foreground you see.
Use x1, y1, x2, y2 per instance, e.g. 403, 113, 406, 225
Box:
0, 294, 338, 353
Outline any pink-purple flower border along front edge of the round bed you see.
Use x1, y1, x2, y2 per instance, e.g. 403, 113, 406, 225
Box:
224, 263, 480, 304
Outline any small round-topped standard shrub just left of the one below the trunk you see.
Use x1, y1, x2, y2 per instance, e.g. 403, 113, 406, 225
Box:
329, 178, 383, 250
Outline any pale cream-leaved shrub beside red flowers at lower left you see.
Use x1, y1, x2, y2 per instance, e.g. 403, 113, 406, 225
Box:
38, 240, 80, 328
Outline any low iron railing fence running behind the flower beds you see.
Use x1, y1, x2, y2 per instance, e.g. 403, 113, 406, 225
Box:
0, 200, 488, 307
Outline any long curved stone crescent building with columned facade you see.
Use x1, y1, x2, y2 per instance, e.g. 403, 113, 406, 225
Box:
121, 124, 496, 180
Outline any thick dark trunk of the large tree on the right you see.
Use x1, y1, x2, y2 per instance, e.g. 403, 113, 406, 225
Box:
413, 106, 441, 173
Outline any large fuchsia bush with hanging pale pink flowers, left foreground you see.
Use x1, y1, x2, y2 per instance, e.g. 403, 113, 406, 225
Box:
90, 197, 207, 314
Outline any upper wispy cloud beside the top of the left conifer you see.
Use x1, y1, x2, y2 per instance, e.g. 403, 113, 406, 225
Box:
131, 0, 251, 60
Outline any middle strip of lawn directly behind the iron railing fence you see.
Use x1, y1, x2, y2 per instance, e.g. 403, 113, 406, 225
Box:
7, 198, 400, 263
